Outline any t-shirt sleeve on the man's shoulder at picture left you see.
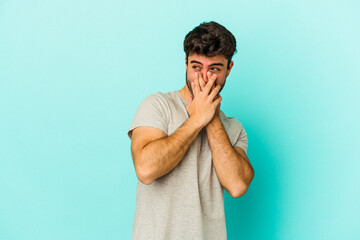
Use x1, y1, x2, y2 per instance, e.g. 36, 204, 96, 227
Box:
128, 92, 169, 139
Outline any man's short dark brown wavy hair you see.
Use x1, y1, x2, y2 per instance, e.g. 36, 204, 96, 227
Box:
184, 21, 236, 68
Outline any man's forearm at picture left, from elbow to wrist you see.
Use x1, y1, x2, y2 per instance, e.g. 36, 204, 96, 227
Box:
141, 117, 202, 184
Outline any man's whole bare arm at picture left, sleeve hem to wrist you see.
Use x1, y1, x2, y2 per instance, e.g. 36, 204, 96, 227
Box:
131, 117, 202, 184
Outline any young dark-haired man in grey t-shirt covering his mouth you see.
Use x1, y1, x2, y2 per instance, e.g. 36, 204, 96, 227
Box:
128, 22, 254, 240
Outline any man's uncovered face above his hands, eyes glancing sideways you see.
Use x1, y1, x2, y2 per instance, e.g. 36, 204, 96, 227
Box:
185, 54, 234, 97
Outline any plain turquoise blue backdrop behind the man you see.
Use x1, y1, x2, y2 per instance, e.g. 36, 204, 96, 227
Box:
0, 0, 360, 240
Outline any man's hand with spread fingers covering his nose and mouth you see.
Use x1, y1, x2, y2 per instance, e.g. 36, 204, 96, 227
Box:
186, 73, 222, 127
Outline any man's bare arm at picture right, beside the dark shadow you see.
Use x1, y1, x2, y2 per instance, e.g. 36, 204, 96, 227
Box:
206, 114, 254, 198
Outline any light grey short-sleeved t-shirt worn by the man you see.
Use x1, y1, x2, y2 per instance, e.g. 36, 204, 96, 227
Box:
128, 91, 248, 240
